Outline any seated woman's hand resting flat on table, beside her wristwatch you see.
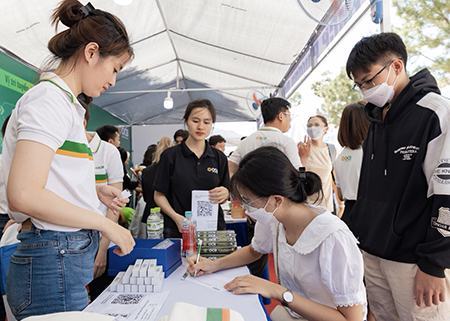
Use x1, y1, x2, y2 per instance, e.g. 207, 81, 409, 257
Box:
225, 275, 284, 299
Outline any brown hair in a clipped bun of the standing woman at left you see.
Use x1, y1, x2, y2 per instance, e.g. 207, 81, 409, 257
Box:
48, 0, 134, 61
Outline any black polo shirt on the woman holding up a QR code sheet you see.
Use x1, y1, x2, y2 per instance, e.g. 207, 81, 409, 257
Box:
154, 143, 230, 235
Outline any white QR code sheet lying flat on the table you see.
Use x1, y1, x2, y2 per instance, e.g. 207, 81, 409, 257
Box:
84, 291, 169, 321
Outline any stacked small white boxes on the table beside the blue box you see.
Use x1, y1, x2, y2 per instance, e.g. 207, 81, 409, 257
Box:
108, 259, 164, 293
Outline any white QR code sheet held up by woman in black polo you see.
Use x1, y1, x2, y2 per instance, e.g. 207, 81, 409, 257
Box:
192, 191, 219, 231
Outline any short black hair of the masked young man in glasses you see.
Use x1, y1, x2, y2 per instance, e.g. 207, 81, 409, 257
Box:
346, 32, 408, 79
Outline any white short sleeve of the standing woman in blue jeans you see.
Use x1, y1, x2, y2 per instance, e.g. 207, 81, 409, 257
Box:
17, 84, 73, 151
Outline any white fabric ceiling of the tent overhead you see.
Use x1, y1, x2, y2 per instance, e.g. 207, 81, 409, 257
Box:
0, 0, 329, 124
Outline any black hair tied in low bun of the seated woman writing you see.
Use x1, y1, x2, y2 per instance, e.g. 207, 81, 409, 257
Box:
231, 146, 323, 203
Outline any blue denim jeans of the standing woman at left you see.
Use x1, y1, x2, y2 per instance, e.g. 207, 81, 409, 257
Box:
6, 227, 99, 320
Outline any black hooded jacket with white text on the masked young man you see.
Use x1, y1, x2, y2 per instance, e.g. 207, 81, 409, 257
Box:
350, 69, 450, 277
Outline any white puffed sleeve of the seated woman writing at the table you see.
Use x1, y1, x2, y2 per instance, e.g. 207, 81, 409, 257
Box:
319, 230, 366, 307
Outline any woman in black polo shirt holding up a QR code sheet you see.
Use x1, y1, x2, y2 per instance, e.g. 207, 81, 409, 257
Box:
154, 99, 230, 238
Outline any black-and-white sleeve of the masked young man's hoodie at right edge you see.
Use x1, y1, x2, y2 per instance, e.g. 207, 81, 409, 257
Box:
416, 98, 450, 278
